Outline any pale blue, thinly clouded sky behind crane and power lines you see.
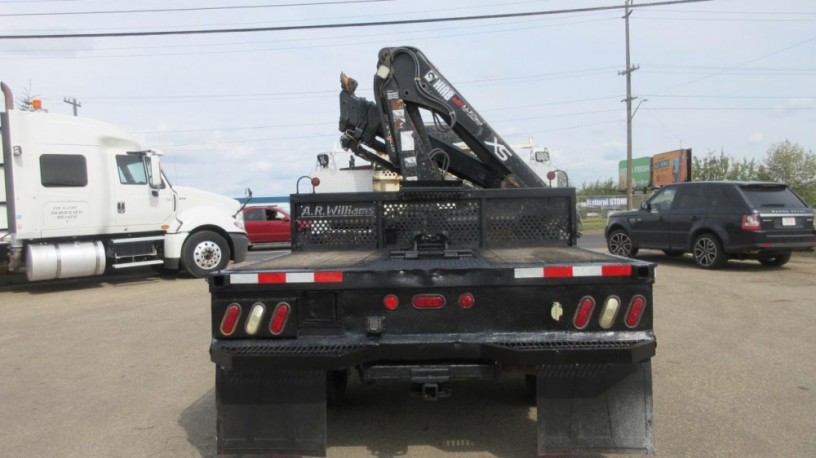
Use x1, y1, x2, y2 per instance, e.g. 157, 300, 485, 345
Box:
0, 0, 816, 196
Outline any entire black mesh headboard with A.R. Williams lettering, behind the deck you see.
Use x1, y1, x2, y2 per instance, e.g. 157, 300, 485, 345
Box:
292, 188, 575, 250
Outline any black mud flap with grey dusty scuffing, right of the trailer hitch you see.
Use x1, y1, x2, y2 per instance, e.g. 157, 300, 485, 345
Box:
536, 361, 654, 456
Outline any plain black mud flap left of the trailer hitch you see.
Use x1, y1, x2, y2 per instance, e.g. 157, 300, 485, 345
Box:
215, 366, 326, 456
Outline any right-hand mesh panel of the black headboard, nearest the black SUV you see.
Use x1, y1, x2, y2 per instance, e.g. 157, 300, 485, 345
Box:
486, 197, 574, 246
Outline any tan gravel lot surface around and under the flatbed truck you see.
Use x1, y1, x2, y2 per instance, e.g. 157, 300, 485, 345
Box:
0, 253, 816, 457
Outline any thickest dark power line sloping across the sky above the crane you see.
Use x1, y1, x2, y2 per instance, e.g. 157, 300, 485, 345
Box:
0, 0, 711, 40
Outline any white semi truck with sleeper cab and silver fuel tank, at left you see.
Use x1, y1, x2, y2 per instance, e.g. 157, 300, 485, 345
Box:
0, 83, 247, 281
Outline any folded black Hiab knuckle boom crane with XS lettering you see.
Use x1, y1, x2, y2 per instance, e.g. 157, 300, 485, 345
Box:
340, 47, 546, 188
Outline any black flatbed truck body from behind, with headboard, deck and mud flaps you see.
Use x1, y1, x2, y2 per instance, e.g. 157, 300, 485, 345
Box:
209, 48, 656, 456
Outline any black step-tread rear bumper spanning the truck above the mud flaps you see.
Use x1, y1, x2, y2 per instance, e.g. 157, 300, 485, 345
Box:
210, 331, 657, 370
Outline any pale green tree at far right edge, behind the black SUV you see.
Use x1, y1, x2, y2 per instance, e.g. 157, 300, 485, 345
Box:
759, 140, 816, 206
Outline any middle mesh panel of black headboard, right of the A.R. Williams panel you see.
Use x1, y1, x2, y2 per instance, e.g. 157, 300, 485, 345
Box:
383, 200, 480, 248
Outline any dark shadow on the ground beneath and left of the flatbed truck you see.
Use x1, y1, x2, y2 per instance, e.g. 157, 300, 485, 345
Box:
179, 377, 556, 458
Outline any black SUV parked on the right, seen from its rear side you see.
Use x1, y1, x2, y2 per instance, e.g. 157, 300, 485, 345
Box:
606, 181, 816, 269
